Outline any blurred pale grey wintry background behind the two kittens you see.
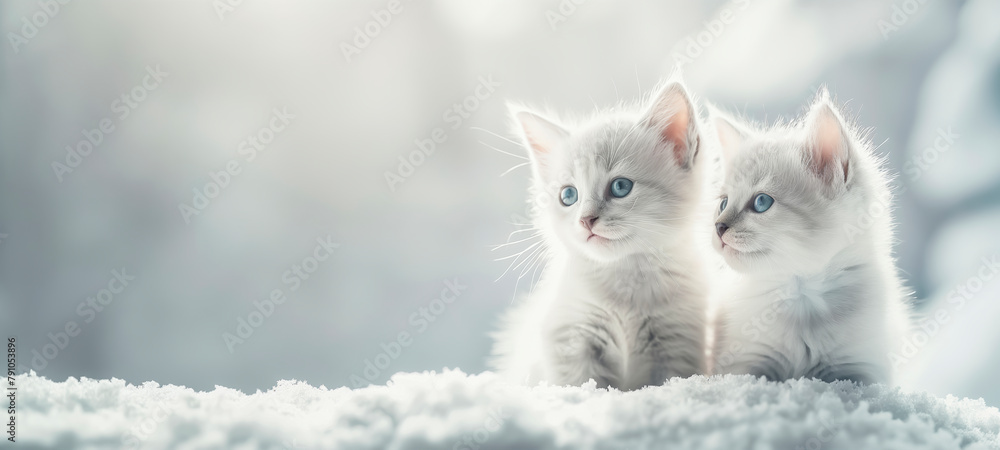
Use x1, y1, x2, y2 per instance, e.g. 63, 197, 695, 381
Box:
0, 0, 1000, 405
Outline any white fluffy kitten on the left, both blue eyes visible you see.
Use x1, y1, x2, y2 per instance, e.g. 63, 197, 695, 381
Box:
492, 82, 710, 389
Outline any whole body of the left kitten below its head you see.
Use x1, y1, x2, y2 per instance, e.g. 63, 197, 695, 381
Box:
494, 217, 705, 390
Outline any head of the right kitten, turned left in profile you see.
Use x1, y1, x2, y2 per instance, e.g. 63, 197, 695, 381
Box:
711, 90, 869, 273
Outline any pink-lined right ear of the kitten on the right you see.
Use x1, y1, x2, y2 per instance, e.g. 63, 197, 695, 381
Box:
806, 89, 853, 184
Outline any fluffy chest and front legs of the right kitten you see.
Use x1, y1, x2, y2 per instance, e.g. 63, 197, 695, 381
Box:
715, 264, 888, 382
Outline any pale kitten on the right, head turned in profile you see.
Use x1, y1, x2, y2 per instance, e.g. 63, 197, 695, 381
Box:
711, 89, 909, 383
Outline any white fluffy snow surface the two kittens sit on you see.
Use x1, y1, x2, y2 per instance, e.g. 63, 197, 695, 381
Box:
17, 370, 1000, 449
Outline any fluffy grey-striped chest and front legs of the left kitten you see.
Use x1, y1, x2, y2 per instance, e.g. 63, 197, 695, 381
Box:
542, 256, 705, 389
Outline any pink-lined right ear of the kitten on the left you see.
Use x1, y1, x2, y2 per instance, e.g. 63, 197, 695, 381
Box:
644, 81, 701, 169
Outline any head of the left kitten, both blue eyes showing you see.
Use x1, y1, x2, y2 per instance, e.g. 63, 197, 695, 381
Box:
513, 82, 700, 262
